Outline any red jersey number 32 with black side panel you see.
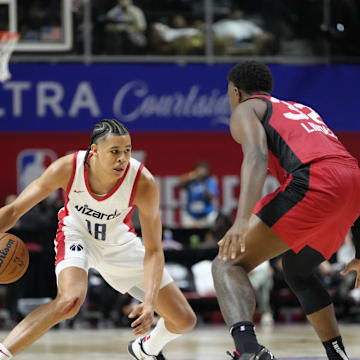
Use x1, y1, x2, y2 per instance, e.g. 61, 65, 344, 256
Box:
251, 95, 357, 184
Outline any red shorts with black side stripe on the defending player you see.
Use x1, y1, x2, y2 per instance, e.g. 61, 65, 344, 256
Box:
254, 159, 360, 259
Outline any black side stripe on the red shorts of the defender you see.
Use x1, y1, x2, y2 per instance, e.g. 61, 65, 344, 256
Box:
256, 164, 310, 227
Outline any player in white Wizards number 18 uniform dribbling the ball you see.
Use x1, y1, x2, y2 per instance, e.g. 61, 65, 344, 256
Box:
0, 120, 196, 360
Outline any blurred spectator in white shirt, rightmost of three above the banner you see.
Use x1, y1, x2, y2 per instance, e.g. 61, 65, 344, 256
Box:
213, 9, 274, 55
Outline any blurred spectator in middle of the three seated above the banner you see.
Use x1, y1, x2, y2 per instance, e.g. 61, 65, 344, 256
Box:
150, 15, 204, 55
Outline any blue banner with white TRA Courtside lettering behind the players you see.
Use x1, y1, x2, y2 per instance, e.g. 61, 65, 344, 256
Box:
0, 63, 360, 132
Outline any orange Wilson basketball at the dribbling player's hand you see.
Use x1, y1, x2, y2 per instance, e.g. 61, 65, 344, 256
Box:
0, 233, 29, 284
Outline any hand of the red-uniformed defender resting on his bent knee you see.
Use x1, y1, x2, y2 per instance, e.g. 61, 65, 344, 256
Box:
218, 221, 249, 261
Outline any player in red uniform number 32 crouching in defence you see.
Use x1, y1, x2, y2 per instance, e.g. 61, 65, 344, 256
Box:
213, 61, 360, 360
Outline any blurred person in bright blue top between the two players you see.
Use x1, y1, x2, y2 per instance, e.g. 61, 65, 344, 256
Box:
179, 161, 218, 228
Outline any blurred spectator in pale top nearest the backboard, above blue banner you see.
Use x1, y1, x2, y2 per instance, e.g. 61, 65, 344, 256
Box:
105, 0, 147, 54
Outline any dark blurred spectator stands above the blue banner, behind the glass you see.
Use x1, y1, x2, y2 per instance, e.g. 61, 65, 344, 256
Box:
9, 0, 360, 56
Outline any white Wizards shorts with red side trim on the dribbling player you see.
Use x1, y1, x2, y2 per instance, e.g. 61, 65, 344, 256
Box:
55, 231, 173, 293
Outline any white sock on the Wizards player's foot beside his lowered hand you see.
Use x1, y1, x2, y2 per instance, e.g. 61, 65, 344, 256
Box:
142, 318, 182, 354
